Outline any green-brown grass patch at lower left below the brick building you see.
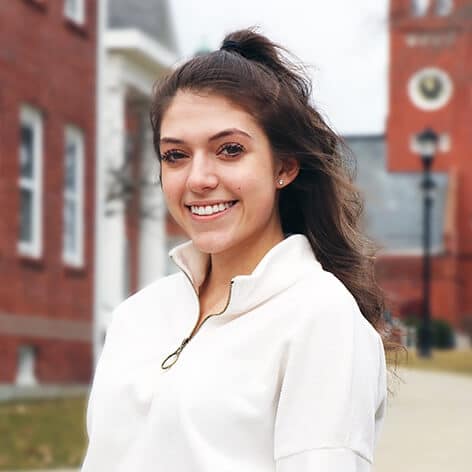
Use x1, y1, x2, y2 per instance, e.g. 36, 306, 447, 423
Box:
0, 396, 87, 470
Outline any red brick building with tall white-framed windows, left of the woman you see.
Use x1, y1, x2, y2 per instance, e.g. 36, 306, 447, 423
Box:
0, 0, 97, 384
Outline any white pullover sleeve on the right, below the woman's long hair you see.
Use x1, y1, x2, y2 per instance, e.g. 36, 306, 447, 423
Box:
274, 294, 386, 472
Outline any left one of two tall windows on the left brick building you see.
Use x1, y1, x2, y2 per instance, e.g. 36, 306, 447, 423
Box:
18, 106, 43, 257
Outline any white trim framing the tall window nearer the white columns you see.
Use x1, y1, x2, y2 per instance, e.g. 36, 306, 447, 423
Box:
62, 125, 85, 267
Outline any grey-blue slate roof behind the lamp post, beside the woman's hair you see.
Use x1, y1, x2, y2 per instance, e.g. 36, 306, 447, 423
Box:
344, 135, 448, 254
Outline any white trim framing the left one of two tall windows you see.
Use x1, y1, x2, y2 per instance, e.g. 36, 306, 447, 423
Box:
17, 105, 43, 258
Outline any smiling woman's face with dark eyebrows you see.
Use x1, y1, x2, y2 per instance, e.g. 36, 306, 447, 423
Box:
160, 91, 288, 254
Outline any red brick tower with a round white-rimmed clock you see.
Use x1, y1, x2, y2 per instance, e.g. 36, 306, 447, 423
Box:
387, 0, 472, 330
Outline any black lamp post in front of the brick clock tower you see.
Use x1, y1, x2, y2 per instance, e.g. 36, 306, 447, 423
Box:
416, 127, 438, 357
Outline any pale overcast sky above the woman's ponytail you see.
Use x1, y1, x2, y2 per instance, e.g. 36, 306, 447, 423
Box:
169, 0, 388, 134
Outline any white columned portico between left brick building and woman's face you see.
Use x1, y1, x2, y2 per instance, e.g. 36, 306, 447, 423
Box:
95, 25, 177, 361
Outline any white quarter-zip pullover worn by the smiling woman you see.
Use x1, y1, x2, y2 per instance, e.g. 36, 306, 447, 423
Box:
82, 234, 387, 472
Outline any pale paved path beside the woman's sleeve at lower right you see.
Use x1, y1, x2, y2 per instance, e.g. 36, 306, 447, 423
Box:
374, 368, 472, 472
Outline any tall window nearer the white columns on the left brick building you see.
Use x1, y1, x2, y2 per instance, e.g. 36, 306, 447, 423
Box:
63, 126, 84, 266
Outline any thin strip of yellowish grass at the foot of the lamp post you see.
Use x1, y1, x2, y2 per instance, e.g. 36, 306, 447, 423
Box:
390, 348, 472, 375
